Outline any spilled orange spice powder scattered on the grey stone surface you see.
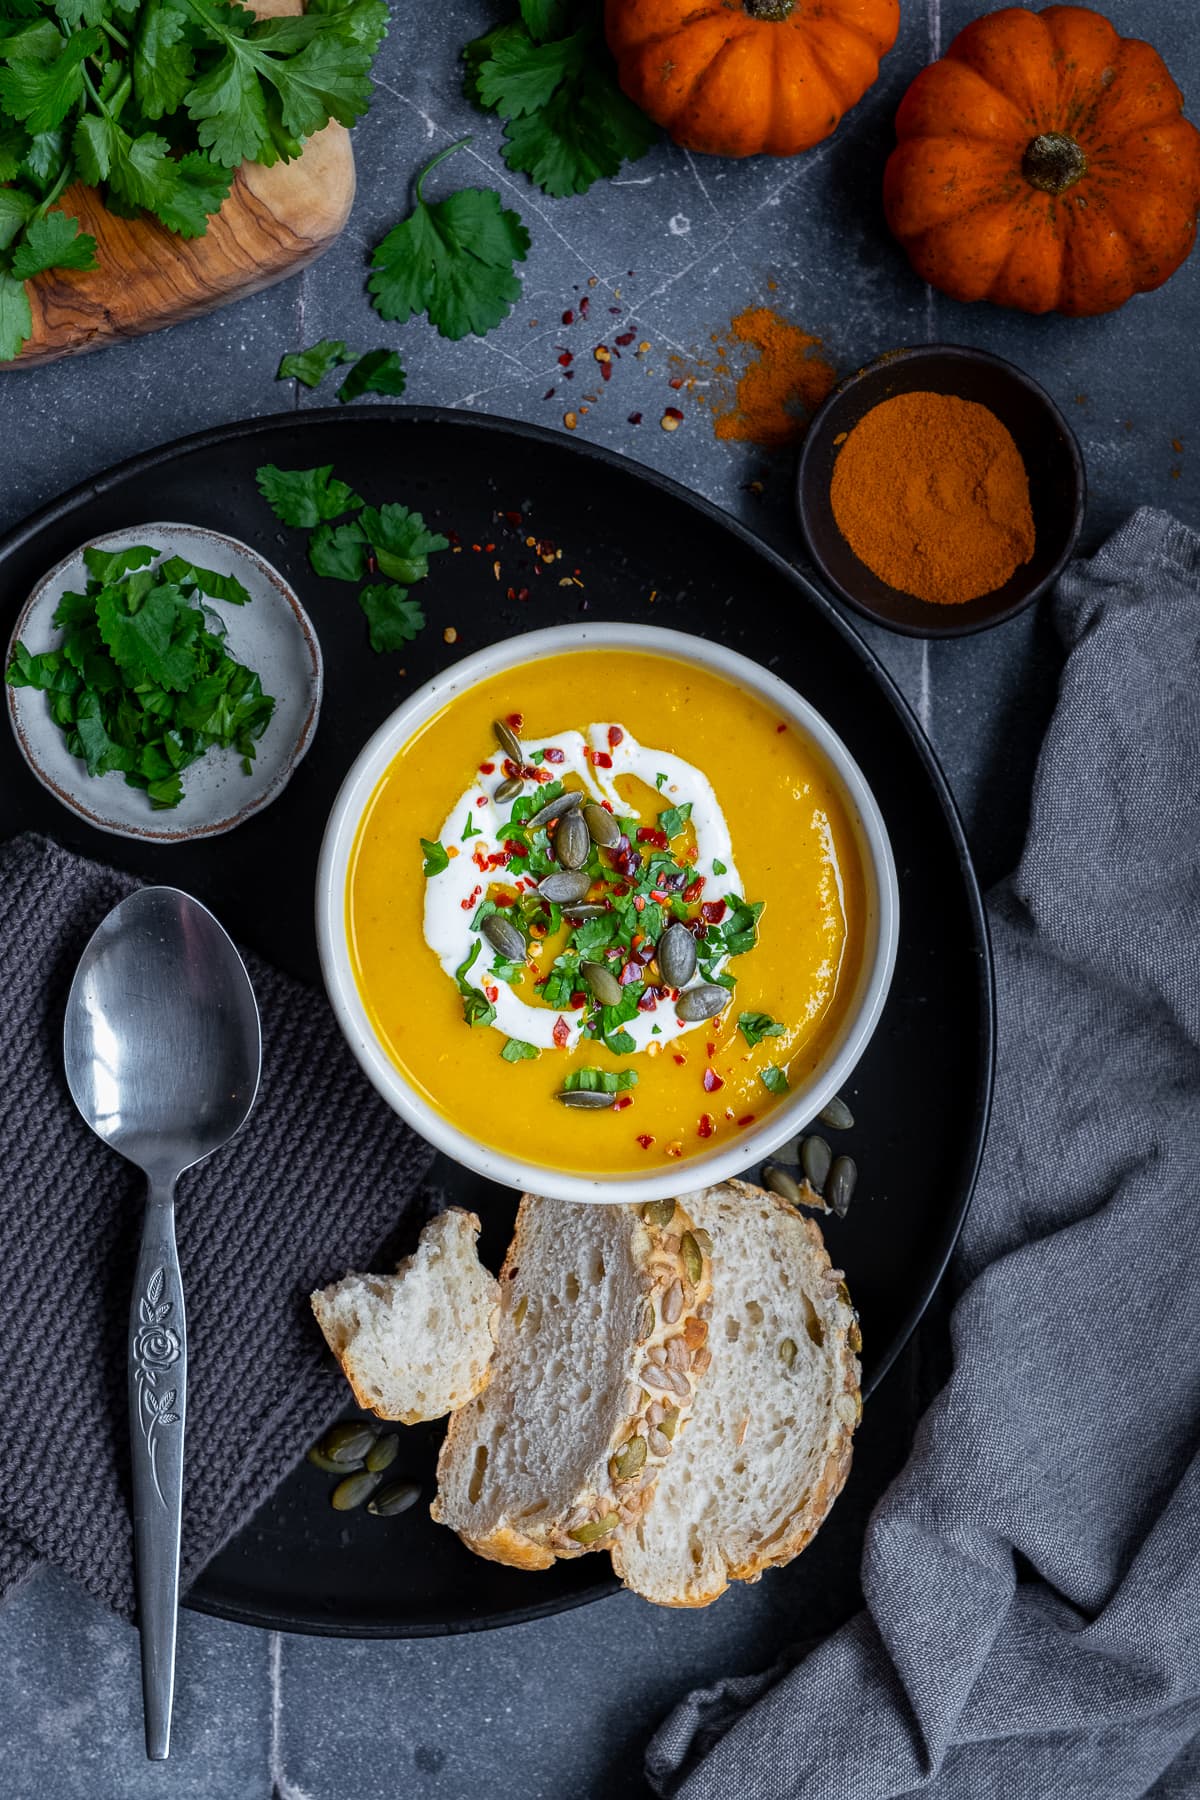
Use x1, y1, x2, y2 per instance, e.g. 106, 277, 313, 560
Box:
671, 306, 837, 450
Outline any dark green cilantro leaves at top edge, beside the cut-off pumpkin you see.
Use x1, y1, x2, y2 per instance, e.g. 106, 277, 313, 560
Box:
462, 0, 658, 198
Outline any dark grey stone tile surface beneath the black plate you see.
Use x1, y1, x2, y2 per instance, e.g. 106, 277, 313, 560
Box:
0, 0, 1200, 1800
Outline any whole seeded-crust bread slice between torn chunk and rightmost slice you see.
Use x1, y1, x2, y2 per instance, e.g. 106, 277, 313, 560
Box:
432, 1193, 709, 1570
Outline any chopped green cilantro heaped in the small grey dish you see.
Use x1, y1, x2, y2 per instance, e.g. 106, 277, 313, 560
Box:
7, 544, 275, 810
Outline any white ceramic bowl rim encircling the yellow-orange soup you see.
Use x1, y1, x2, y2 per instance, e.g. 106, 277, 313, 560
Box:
317, 625, 900, 1204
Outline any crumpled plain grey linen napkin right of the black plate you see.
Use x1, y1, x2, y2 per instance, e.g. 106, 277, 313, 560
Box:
648, 511, 1200, 1800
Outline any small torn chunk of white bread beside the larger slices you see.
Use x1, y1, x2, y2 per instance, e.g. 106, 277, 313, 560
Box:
311, 1206, 500, 1426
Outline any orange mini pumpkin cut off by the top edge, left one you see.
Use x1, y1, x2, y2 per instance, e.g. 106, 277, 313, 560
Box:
604, 0, 900, 157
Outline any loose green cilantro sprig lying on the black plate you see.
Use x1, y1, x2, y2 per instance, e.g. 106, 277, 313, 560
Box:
257, 463, 450, 652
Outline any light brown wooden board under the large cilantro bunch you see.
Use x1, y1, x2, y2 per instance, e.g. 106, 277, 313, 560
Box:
8, 0, 354, 371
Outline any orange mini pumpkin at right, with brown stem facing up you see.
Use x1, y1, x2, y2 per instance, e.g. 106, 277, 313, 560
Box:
883, 5, 1200, 315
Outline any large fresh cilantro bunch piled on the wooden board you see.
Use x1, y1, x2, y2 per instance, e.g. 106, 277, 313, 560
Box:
0, 0, 387, 362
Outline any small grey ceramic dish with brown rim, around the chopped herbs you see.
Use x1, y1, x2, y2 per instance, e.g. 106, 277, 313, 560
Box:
5, 522, 324, 844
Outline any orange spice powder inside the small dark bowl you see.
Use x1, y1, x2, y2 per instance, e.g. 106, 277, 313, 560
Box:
829, 392, 1034, 607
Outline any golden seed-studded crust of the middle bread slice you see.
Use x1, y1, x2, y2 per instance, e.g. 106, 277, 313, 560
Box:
430, 1193, 712, 1568
